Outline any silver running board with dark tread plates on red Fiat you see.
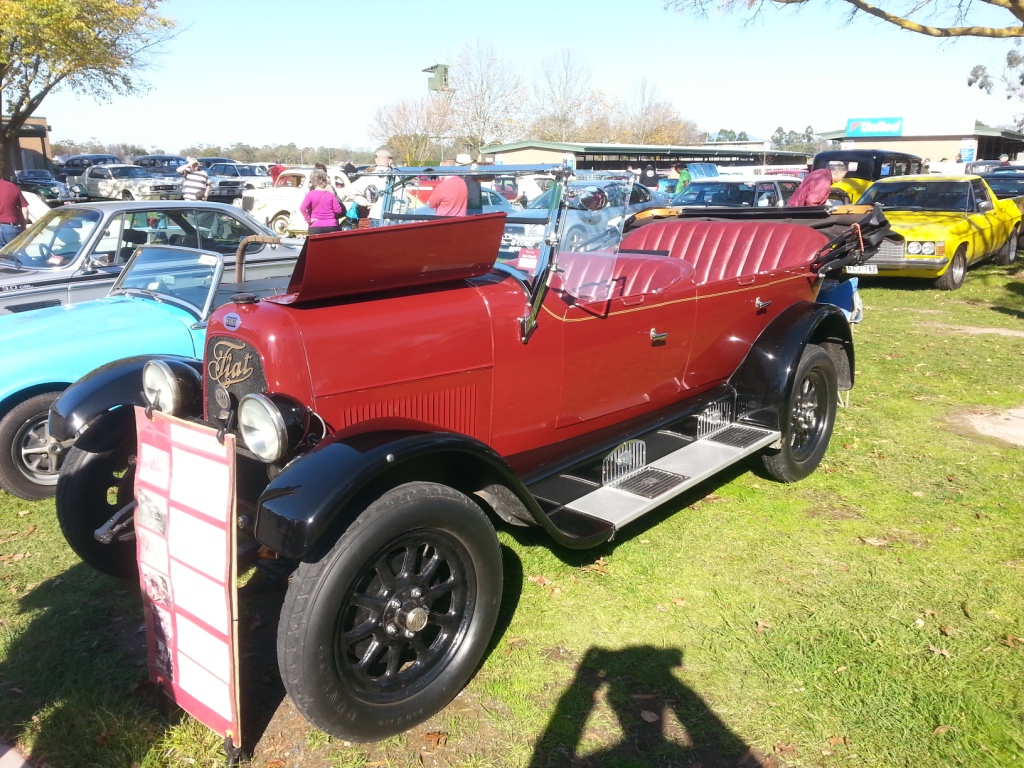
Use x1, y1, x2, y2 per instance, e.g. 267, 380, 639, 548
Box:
564, 424, 782, 528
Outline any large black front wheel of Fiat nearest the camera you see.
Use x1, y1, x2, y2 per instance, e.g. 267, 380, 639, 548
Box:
278, 482, 502, 741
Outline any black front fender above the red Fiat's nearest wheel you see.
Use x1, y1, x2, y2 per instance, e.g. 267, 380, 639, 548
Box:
254, 432, 612, 558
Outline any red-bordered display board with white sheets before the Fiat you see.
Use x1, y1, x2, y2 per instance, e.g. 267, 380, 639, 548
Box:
135, 408, 242, 746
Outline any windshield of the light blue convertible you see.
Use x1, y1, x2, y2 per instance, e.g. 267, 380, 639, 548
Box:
111, 246, 224, 319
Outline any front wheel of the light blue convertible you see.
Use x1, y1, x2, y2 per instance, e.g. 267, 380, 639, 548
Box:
0, 392, 62, 501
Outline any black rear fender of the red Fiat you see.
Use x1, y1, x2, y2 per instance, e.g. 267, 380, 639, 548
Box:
730, 302, 854, 429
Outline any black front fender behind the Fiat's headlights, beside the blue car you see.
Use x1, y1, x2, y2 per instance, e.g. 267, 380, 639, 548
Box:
49, 354, 203, 451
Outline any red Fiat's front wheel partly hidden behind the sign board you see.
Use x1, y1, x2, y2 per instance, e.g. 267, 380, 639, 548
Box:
56, 436, 138, 579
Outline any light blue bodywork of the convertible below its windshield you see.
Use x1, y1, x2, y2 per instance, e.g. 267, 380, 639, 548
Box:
0, 296, 205, 398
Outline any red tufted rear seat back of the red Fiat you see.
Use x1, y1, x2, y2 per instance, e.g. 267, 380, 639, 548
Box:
620, 219, 828, 285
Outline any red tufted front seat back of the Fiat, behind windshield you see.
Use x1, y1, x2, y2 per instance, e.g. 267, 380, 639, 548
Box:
555, 251, 693, 301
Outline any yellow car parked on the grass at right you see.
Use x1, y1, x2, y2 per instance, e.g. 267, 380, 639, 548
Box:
847, 174, 1024, 291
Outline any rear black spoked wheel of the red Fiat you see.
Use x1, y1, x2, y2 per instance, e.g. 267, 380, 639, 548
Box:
762, 344, 839, 482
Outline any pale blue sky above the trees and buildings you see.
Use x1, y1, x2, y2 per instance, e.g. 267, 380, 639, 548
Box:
39, 0, 1024, 152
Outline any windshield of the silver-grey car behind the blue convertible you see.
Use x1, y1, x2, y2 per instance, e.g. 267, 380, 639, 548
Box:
0, 208, 101, 269
